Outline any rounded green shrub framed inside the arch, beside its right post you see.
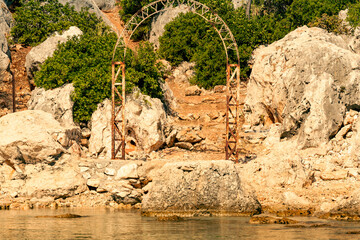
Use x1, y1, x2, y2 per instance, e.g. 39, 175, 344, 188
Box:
159, 13, 226, 88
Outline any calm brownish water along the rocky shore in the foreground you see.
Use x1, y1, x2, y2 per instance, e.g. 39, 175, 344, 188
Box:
0, 209, 360, 240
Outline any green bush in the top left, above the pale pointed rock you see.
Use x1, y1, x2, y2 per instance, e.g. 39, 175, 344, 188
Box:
11, 0, 106, 46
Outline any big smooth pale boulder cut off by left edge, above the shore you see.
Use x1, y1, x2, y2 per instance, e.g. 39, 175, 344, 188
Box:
0, 110, 80, 165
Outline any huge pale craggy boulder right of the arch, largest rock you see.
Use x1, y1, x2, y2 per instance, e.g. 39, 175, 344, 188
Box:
245, 26, 360, 148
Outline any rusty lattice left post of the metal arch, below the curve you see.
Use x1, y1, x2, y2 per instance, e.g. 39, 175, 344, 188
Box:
111, 62, 125, 160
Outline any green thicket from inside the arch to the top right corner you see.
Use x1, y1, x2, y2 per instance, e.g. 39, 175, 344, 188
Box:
146, 0, 360, 88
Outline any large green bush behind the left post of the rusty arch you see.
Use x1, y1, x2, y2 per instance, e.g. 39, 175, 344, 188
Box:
34, 33, 161, 122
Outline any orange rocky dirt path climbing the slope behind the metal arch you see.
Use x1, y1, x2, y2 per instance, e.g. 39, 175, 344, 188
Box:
149, 63, 262, 160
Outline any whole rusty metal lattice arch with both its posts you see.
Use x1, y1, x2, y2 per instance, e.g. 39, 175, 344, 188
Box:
111, 0, 242, 162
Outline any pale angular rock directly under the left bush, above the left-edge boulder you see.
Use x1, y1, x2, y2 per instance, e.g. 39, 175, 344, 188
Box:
28, 83, 74, 126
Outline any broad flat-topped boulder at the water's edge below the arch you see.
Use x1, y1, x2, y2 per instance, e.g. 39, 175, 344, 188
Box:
142, 161, 261, 215
